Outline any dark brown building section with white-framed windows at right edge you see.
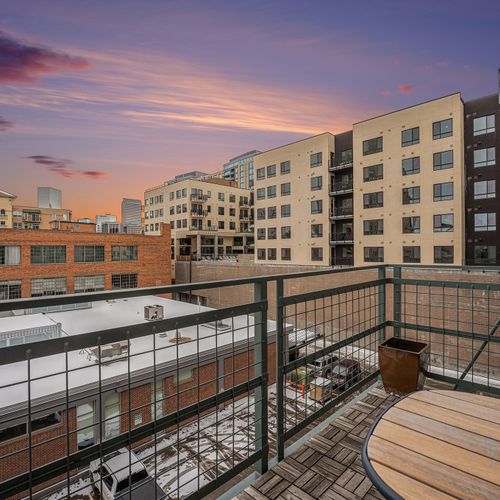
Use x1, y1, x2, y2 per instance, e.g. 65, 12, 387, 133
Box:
464, 94, 500, 265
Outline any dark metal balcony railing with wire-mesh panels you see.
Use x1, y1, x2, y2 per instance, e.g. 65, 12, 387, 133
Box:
0, 265, 500, 498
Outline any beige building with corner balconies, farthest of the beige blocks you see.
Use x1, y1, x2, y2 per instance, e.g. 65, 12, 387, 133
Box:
144, 172, 253, 258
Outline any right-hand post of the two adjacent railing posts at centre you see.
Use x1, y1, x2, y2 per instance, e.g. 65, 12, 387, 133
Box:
276, 278, 288, 461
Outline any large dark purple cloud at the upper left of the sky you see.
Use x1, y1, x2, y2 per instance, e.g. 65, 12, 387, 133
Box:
0, 31, 89, 83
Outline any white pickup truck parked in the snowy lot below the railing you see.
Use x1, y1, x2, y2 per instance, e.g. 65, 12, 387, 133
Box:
90, 448, 166, 500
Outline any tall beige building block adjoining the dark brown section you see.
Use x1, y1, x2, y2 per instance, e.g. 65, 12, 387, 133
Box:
353, 93, 464, 265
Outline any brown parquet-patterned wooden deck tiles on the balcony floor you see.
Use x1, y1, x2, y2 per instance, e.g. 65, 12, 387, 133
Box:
236, 386, 397, 500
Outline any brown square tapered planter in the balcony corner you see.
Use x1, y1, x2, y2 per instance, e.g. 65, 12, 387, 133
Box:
378, 337, 429, 394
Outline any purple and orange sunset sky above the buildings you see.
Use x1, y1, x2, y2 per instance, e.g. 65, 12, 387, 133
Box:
0, 0, 500, 217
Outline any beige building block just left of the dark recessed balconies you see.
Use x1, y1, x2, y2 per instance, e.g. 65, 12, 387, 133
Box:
254, 132, 335, 266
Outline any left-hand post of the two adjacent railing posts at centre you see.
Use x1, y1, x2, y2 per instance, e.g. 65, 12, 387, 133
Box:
254, 281, 269, 474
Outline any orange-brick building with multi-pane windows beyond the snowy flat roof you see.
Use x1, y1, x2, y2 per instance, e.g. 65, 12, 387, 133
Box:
0, 224, 171, 300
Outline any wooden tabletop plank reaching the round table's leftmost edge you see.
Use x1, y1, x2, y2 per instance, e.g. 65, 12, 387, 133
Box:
368, 436, 500, 499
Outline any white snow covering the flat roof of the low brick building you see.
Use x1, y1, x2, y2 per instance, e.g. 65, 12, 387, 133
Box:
0, 296, 276, 413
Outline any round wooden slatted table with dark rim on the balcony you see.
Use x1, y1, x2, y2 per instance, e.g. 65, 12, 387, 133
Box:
362, 390, 500, 499
